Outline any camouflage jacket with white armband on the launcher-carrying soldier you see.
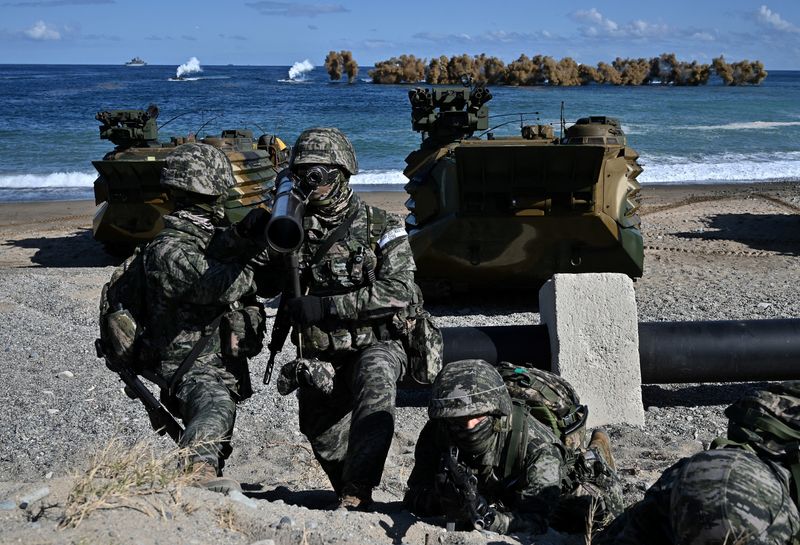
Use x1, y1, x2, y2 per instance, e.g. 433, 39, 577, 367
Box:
294, 194, 416, 355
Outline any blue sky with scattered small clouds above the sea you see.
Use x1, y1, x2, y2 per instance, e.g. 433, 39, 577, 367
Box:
0, 0, 800, 70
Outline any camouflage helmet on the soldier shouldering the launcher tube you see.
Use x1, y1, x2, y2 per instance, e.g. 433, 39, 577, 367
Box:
291, 127, 358, 176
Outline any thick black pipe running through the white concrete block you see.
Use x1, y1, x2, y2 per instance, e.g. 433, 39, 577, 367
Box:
442, 319, 800, 384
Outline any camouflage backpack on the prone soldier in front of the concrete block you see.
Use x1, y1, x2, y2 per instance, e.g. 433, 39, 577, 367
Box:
495, 361, 589, 449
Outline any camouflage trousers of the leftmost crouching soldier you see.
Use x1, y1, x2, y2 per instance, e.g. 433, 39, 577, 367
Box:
159, 355, 239, 470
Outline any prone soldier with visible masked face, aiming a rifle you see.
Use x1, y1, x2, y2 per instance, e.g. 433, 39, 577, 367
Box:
403, 360, 622, 534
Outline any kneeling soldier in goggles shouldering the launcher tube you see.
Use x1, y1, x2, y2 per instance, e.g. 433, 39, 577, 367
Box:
268, 128, 418, 509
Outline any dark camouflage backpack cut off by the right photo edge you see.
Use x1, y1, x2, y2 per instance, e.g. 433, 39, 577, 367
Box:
711, 380, 800, 504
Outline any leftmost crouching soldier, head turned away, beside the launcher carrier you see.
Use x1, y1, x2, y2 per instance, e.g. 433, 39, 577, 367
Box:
143, 143, 264, 492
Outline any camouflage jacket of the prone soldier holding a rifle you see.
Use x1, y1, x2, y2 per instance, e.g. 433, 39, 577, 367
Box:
403, 413, 567, 533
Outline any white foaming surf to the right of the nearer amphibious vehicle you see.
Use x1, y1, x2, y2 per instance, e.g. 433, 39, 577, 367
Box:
638, 152, 800, 183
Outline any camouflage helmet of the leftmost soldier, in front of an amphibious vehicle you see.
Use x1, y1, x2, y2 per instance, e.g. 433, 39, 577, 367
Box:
161, 143, 236, 197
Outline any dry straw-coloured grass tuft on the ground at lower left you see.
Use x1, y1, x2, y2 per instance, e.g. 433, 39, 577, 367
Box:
59, 438, 206, 528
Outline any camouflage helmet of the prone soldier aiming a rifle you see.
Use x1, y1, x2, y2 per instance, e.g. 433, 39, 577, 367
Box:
428, 360, 511, 418
